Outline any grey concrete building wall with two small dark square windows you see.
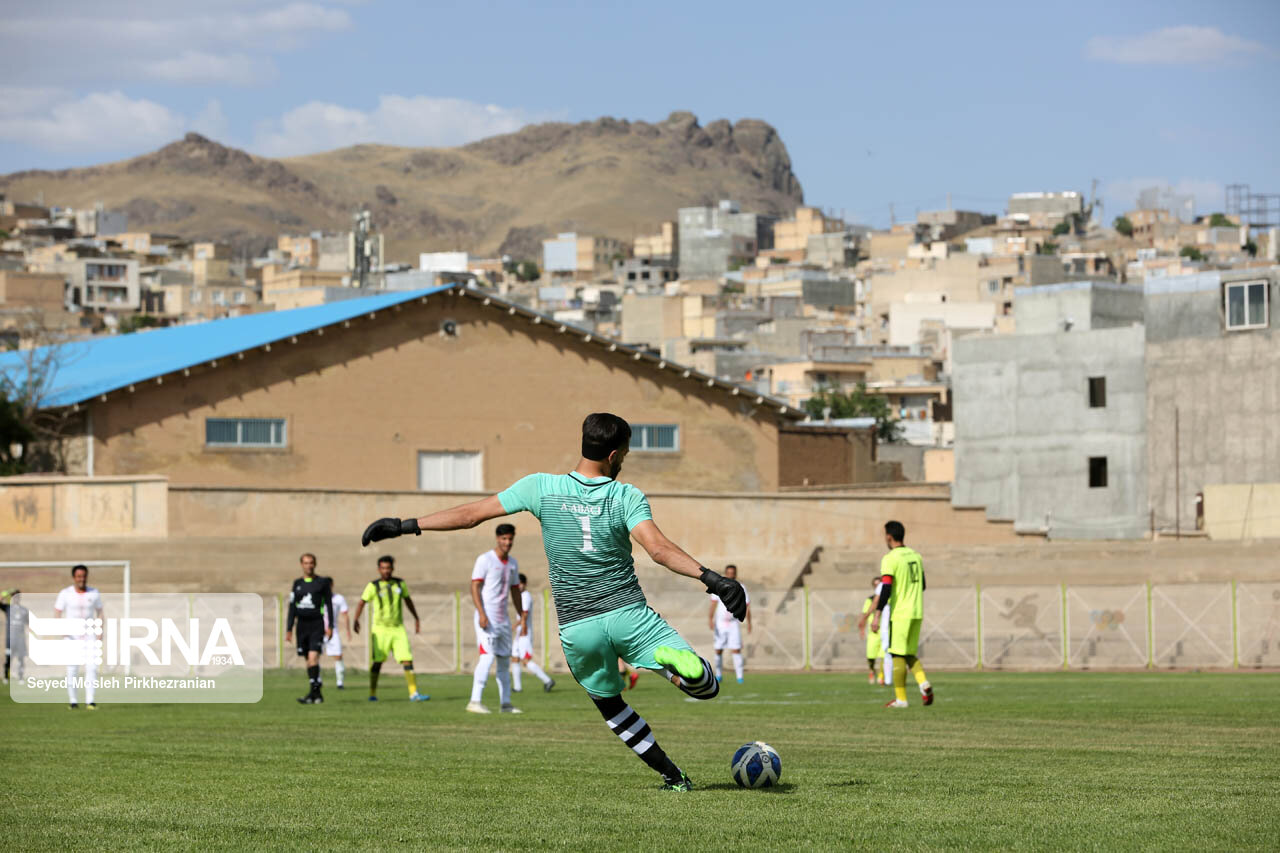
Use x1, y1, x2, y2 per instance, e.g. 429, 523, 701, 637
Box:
952, 327, 1148, 539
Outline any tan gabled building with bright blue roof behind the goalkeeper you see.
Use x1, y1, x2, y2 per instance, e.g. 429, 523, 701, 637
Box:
0, 286, 880, 492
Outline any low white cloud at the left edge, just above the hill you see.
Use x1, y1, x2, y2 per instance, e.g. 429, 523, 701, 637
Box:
0, 87, 227, 152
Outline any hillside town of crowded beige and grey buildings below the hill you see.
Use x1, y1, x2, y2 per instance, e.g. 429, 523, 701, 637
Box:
0, 184, 1280, 538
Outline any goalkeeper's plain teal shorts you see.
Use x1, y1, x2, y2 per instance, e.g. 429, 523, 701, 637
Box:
561, 605, 694, 699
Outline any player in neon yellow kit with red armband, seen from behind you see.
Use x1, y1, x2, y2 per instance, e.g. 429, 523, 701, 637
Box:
872, 521, 933, 708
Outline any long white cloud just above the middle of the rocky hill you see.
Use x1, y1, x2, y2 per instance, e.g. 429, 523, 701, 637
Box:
252, 95, 545, 156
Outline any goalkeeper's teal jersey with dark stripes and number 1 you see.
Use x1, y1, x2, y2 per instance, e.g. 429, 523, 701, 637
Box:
498, 471, 653, 625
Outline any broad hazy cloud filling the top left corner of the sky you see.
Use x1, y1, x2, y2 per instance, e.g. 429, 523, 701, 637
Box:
0, 0, 353, 86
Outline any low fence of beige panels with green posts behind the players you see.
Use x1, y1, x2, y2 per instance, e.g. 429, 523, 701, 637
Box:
264, 581, 1280, 672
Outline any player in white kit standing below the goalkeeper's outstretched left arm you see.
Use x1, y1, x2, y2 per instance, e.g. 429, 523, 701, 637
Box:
467, 524, 524, 713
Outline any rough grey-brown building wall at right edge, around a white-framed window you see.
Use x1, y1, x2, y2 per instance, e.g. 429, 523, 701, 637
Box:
1146, 268, 1280, 530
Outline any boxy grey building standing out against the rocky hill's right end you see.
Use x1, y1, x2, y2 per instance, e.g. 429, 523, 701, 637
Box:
677, 200, 773, 278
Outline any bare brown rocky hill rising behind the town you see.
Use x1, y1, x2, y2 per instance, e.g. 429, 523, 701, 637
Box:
0, 113, 804, 263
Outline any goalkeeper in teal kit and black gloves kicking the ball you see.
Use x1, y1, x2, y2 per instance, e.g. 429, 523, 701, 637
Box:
361, 414, 746, 792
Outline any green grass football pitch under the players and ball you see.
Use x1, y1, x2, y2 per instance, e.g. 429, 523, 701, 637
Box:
0, 671, 1280, 850
